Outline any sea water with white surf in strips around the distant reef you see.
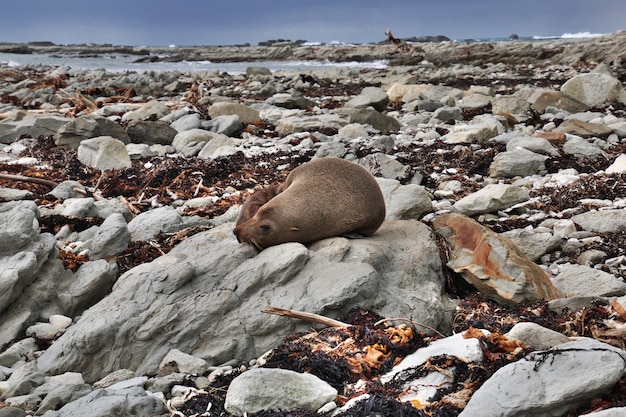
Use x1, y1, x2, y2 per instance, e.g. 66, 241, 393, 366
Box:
0, 32, 601, 74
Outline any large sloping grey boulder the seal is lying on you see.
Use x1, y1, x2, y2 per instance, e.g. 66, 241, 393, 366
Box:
38, 220, 444, 382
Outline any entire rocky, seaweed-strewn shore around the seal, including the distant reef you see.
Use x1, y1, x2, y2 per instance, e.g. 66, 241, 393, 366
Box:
0, 32, 626, 417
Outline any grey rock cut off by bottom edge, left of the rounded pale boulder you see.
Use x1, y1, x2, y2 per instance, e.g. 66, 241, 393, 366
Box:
41, 387, 167, 417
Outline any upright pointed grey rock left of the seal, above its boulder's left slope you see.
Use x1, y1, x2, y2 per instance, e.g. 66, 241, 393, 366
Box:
89, 213, 130, 260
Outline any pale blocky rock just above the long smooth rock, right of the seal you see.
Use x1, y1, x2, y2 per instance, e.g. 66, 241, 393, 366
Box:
489, 149, 548, 178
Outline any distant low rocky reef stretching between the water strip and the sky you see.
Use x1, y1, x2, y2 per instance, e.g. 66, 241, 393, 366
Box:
0, 32, 626, 66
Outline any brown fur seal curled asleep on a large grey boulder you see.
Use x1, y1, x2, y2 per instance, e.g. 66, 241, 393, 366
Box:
234, 158, 385, 249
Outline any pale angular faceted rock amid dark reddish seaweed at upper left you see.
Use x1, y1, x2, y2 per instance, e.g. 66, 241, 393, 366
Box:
78, 136, 132, 171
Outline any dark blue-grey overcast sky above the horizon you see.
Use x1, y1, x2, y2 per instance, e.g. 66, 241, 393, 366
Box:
0, 0, 626, 46
